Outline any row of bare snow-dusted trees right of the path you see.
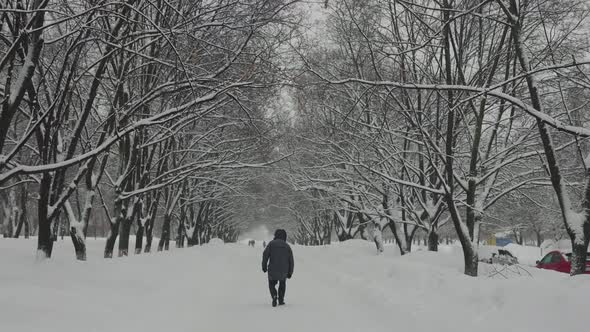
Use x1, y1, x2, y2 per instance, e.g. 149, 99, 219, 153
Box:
290, 0, 590, 276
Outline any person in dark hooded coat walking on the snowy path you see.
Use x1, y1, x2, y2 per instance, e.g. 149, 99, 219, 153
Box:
262, 229, 295, 307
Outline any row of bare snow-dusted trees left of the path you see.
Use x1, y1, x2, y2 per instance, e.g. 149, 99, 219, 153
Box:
0, 0, 291, 260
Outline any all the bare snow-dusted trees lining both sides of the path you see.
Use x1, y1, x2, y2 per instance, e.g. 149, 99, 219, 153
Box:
0, 0, 590, 276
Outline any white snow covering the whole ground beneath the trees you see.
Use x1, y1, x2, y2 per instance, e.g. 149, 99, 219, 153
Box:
0, 239, 590, 332
